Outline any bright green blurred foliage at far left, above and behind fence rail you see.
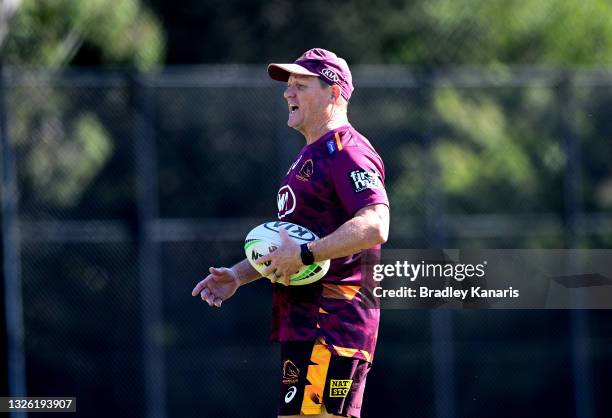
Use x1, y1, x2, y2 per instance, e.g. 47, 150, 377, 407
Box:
0, 0, 165, 208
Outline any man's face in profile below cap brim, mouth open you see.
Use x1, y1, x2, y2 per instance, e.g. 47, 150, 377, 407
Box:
284, 74, 330, 133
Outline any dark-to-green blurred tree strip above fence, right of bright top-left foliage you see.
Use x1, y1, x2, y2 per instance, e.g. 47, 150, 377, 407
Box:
165, 0, 612, 67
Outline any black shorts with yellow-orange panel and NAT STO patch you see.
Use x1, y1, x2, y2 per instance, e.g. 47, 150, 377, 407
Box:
278, 341, 371, 418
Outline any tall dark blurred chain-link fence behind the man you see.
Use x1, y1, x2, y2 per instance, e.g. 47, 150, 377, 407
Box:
1, 66, 612, 418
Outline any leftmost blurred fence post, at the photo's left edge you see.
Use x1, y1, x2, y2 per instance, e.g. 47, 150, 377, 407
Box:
0, 59, 27, 418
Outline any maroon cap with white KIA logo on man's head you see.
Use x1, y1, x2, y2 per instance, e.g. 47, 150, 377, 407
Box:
268, 48, 353, 100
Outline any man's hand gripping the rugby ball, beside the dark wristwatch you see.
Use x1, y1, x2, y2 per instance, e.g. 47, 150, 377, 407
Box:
257, 228, 303, 286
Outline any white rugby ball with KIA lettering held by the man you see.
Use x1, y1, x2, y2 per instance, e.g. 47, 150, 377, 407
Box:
244, 221, 329, 286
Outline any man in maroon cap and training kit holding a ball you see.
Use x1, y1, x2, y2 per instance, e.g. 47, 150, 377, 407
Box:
192, 48, 389, 417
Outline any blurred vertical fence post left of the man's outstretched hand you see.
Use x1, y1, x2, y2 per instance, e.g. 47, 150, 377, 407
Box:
131, 75, 167, 418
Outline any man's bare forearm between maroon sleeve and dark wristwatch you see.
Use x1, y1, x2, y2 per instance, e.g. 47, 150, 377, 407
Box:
308, 207, 389, 261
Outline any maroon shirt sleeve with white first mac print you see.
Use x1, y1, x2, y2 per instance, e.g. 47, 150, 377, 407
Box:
331, 147, 389, 216
